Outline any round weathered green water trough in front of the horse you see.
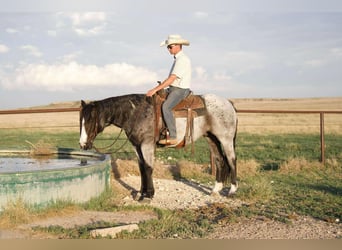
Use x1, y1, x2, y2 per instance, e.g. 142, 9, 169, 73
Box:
0, 148, 111, 211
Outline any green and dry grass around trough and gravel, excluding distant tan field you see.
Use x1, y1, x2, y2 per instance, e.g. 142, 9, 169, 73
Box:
0, 130, 342, 239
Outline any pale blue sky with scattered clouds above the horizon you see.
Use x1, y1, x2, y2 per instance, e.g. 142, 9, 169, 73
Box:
0, 0, 342, 109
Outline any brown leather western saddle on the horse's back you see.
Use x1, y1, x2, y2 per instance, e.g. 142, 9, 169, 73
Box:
153, 90, 206, 150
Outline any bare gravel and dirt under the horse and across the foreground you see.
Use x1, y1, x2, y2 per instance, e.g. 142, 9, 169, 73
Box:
0, 176, 342, 239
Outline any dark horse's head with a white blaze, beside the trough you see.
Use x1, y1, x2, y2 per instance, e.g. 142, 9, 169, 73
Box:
80, 101, 103, 149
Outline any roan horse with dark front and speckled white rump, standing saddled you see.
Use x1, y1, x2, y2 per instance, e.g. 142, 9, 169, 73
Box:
80, 94, 237, 200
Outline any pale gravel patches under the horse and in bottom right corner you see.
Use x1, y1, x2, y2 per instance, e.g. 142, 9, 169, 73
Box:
120, 176, 342, 239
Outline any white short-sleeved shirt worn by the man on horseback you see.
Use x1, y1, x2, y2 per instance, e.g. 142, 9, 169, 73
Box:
170, 50, 191, 89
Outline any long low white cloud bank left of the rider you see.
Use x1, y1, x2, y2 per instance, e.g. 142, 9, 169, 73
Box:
0, 61, 158, 91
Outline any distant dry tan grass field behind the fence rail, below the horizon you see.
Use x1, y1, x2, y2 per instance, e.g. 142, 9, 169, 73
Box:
0, 97, 342, 134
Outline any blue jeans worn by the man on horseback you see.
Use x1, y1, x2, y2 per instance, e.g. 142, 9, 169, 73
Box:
162, 86, 190, 138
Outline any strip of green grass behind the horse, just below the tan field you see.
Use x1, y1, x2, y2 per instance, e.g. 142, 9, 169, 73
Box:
0, 130, 342, 164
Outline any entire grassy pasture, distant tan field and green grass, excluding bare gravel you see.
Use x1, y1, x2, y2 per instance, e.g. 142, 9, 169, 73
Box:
0, 98, 342, 238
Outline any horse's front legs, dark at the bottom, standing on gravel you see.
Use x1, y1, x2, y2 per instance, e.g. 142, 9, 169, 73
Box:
136, 143, 154, 201
